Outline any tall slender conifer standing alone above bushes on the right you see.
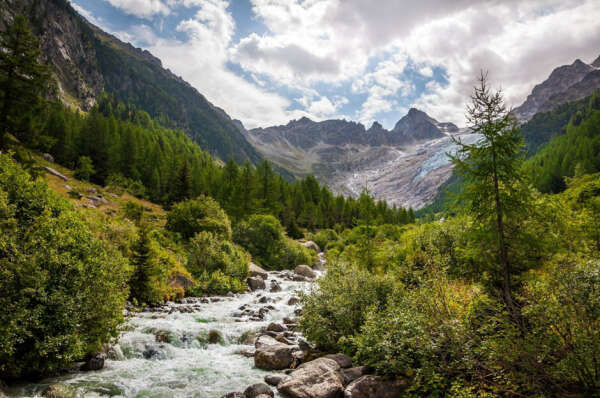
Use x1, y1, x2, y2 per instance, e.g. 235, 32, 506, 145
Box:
450, 73, 530, 322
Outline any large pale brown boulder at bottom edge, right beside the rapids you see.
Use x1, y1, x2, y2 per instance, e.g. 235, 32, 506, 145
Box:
277, 358, 344, 398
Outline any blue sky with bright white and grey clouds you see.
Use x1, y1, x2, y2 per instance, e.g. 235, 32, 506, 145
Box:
71, 0, 600, 128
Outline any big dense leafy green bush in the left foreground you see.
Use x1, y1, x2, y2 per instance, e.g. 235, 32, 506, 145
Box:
0, 155, 128, 378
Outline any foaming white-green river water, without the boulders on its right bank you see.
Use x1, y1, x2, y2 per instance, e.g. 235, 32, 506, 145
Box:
9, 272, 318, 398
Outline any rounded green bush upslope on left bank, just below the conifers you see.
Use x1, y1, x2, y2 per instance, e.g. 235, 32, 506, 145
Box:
165, 195, 231, 240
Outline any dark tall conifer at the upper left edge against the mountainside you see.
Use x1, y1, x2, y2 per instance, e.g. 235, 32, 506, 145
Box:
0, 15, 50, 149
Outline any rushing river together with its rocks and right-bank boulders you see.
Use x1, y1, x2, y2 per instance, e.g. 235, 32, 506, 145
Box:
8, 247, 406, 398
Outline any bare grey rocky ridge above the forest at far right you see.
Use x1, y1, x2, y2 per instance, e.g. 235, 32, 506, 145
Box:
514, 58, 600, 122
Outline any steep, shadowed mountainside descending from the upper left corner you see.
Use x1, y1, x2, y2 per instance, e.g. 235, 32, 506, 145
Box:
0, 0, 262, 163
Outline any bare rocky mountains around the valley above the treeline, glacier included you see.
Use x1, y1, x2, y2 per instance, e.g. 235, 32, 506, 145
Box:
0, 0, 600, 209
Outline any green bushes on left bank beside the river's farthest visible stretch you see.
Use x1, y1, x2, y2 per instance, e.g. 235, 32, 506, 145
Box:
234, 215, 316, 269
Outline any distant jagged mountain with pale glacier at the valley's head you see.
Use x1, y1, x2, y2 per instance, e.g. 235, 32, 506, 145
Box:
246, 109, 473, 208
